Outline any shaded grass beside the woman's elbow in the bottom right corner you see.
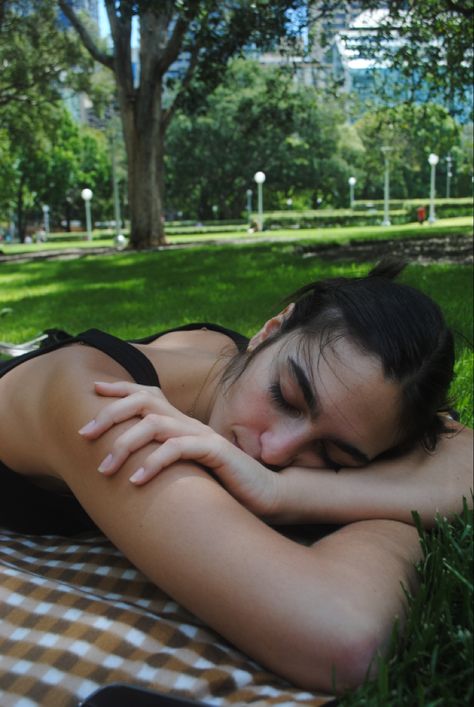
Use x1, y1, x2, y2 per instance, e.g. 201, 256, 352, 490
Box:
340, 504, 474, 707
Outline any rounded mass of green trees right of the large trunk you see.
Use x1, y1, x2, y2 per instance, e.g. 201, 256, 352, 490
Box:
165, 67, 472, 218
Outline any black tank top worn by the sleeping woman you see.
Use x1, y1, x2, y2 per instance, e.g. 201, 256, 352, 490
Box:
0, 323, 248, 535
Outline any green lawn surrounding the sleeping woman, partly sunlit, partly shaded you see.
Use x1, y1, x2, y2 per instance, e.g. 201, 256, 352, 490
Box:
0, 241, 473, 707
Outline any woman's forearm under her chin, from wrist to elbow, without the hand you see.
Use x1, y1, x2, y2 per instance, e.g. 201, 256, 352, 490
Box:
268, 428, 473, 527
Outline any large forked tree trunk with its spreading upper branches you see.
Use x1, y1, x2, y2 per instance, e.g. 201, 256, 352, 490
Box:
58, 0, 312, 248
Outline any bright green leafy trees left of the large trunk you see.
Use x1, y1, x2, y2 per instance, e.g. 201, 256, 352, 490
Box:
0, 103, 112, 238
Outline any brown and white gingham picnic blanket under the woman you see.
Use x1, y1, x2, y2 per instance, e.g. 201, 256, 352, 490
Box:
0, 529, 330, 707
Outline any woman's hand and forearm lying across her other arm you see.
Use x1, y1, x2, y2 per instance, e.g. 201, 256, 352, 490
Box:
81, 384, 473, 527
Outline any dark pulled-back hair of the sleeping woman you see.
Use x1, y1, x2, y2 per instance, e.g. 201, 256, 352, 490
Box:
229, 260, 454, 455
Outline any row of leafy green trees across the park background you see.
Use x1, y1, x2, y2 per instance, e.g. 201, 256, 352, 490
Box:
0, 0, 472, 242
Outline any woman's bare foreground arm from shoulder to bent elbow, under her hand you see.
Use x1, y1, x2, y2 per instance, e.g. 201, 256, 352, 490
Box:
2, 347, 419, 690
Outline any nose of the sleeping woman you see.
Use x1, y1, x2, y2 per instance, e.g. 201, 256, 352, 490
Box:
260, 423, 314, 466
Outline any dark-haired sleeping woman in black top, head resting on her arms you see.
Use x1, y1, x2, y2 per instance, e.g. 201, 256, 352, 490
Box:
0, 267, 472, 691
